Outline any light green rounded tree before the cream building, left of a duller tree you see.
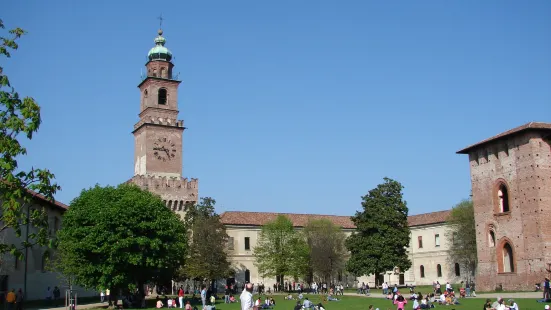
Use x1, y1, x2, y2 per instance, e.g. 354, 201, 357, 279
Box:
253, 215, 310, 281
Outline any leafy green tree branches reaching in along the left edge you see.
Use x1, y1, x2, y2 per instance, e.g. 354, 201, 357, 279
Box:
0, 20, 60, 259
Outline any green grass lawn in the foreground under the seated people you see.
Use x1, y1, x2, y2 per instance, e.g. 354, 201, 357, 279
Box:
132, 295, 545, 310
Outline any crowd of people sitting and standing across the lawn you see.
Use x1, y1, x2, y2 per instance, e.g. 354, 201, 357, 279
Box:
88, 278, 551, 310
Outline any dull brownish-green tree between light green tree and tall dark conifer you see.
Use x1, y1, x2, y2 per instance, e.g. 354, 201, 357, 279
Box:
303, 219, 348, 282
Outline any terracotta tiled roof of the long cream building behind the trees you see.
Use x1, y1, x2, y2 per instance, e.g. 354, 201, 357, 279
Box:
221, 211, 450, 229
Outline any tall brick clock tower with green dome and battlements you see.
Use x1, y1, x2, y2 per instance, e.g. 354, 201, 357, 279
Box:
129, 30, 199, 215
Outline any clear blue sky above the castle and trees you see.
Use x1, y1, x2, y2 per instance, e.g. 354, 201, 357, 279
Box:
4, 0, 551, 215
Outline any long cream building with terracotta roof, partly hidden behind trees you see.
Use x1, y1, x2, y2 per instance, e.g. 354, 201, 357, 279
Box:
221, 211, 466, 287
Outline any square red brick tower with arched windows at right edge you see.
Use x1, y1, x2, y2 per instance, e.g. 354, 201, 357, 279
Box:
457, 123, 551, 290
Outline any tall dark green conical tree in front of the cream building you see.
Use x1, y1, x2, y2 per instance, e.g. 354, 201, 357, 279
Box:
346, 178, 411, 284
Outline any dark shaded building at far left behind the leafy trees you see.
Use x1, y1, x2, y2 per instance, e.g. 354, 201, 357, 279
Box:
0, 191, 97, 300
